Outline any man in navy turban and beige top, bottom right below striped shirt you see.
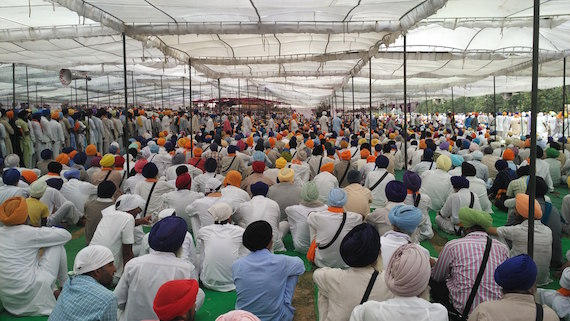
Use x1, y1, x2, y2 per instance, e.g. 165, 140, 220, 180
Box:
469, 254, 560, 321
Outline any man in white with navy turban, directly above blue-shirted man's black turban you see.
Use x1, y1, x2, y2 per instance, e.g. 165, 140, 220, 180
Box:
235, 182, 289, 251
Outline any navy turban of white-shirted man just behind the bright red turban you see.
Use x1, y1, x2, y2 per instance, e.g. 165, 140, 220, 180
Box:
148, 216, 188, 252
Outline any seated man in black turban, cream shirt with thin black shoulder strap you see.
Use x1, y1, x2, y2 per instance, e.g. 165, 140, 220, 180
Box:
313, 223, 394, 321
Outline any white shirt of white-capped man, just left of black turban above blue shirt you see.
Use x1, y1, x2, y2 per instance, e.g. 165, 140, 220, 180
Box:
196, 224, 249, 292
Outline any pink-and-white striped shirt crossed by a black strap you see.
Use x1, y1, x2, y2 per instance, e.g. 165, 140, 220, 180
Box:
431, 232, 509, 312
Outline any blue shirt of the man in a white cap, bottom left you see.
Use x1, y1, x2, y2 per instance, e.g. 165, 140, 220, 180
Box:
49, 275, 117, 321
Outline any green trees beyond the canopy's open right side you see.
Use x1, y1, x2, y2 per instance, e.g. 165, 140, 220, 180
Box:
416, 87, 562, 113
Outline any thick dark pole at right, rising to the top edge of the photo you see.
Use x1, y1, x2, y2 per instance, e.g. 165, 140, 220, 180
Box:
524, 0, 540, 257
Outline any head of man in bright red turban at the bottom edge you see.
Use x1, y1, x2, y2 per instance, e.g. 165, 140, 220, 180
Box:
152, 280, 200, 321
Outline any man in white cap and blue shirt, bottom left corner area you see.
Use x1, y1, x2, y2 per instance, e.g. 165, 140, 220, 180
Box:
49, 245, 117, 321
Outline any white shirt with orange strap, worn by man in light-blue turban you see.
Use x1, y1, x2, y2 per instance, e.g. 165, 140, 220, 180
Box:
307, 210, 362, 268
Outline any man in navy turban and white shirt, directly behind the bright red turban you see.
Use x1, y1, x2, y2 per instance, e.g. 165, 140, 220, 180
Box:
115, 216, 205, 320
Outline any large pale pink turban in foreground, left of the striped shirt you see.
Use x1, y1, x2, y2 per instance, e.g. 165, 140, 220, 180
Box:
384, 243, 431, 297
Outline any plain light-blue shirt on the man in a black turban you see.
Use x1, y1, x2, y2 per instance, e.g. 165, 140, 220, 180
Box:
232, 249, 305, 321
